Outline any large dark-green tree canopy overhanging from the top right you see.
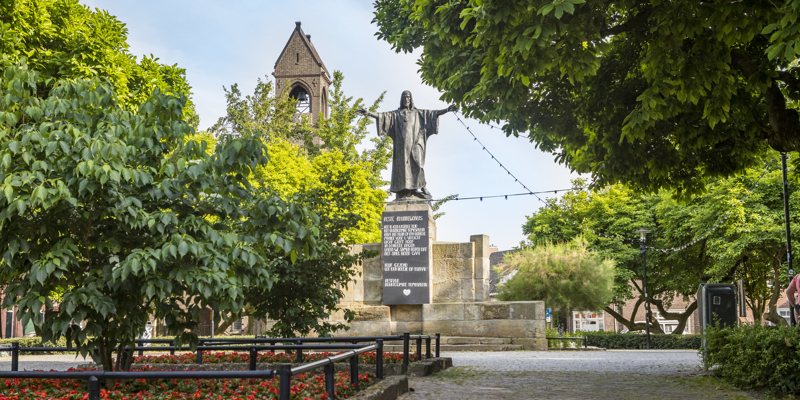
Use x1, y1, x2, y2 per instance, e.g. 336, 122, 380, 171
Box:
374, 0, 800, 195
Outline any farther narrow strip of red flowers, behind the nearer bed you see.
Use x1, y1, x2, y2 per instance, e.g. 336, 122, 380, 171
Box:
133, 351, 417, 364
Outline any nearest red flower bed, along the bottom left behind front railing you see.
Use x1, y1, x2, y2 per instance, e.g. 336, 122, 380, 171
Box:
0, 368, 375, 400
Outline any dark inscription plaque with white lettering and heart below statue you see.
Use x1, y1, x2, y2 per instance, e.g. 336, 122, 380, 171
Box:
381, 211, 431, 305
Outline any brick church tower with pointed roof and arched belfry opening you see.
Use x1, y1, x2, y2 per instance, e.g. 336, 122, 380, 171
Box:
272, 21, 331, 125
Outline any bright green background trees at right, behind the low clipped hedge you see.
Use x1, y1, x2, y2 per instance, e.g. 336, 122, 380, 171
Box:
523, 162, 800, 333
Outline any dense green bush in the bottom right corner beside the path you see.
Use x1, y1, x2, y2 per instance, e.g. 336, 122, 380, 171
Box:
701, 325, 800, 395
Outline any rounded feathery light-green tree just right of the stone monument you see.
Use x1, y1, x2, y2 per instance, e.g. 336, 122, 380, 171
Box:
498, 238, 614, 321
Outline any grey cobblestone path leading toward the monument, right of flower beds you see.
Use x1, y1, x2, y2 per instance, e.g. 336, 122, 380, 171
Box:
400, 350, 752, 400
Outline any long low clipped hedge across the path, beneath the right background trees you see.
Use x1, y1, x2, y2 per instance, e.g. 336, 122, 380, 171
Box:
586, 332, 700, 350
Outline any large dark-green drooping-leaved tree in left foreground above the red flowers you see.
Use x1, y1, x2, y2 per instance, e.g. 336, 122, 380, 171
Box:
0, 65, 318, 370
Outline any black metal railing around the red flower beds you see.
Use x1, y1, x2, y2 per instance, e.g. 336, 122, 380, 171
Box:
0, 332, 441, 400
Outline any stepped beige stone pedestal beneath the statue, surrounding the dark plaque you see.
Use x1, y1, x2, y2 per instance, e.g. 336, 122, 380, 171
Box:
331, 202, 547, 350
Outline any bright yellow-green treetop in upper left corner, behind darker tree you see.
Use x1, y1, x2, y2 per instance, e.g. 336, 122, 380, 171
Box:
0, 0, 199, 128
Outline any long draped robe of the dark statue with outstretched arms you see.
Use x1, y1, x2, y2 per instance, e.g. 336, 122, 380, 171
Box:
377, 109, 439, 193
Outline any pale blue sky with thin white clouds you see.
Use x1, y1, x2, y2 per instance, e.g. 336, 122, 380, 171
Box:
82, 0, 578, 250
